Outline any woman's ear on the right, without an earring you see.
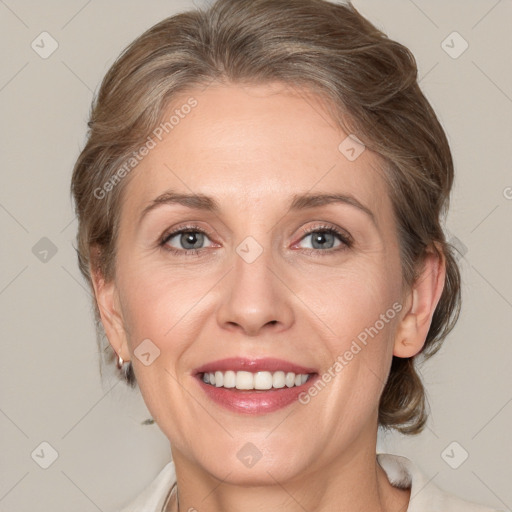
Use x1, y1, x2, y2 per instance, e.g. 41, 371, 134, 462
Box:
393, 248, 446, 357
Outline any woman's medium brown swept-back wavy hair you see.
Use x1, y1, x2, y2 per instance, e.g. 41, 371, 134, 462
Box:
71, 0, 460, 434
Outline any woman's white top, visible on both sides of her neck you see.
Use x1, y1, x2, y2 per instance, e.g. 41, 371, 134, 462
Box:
121, 453, 499, 512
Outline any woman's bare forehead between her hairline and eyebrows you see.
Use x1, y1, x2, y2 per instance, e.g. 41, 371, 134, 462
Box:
123, 83, 387, 220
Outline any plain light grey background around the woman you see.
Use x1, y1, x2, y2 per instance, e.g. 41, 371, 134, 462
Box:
0, 0, 512, 512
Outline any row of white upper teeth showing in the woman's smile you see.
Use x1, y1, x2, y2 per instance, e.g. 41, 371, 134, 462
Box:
203, 370, 309, 390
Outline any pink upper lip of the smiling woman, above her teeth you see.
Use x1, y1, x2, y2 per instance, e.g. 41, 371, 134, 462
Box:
194, 357, 316, 374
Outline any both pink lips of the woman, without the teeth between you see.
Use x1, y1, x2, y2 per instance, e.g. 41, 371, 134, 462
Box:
194, 357, 319, 414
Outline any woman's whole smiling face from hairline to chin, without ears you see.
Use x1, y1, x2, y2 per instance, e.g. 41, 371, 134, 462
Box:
104, 84, 408, 483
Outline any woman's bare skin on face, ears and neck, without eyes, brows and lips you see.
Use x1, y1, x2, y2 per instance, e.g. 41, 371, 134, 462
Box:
94, 83, 445, 512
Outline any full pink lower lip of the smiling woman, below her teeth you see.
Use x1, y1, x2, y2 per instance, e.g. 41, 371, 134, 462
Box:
197, 374, 318, 414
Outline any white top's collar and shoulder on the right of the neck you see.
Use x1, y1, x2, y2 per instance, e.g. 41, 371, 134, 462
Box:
377, 453, 499, 512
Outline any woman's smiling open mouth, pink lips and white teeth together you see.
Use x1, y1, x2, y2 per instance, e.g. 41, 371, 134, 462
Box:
194, 358, 319, 414
